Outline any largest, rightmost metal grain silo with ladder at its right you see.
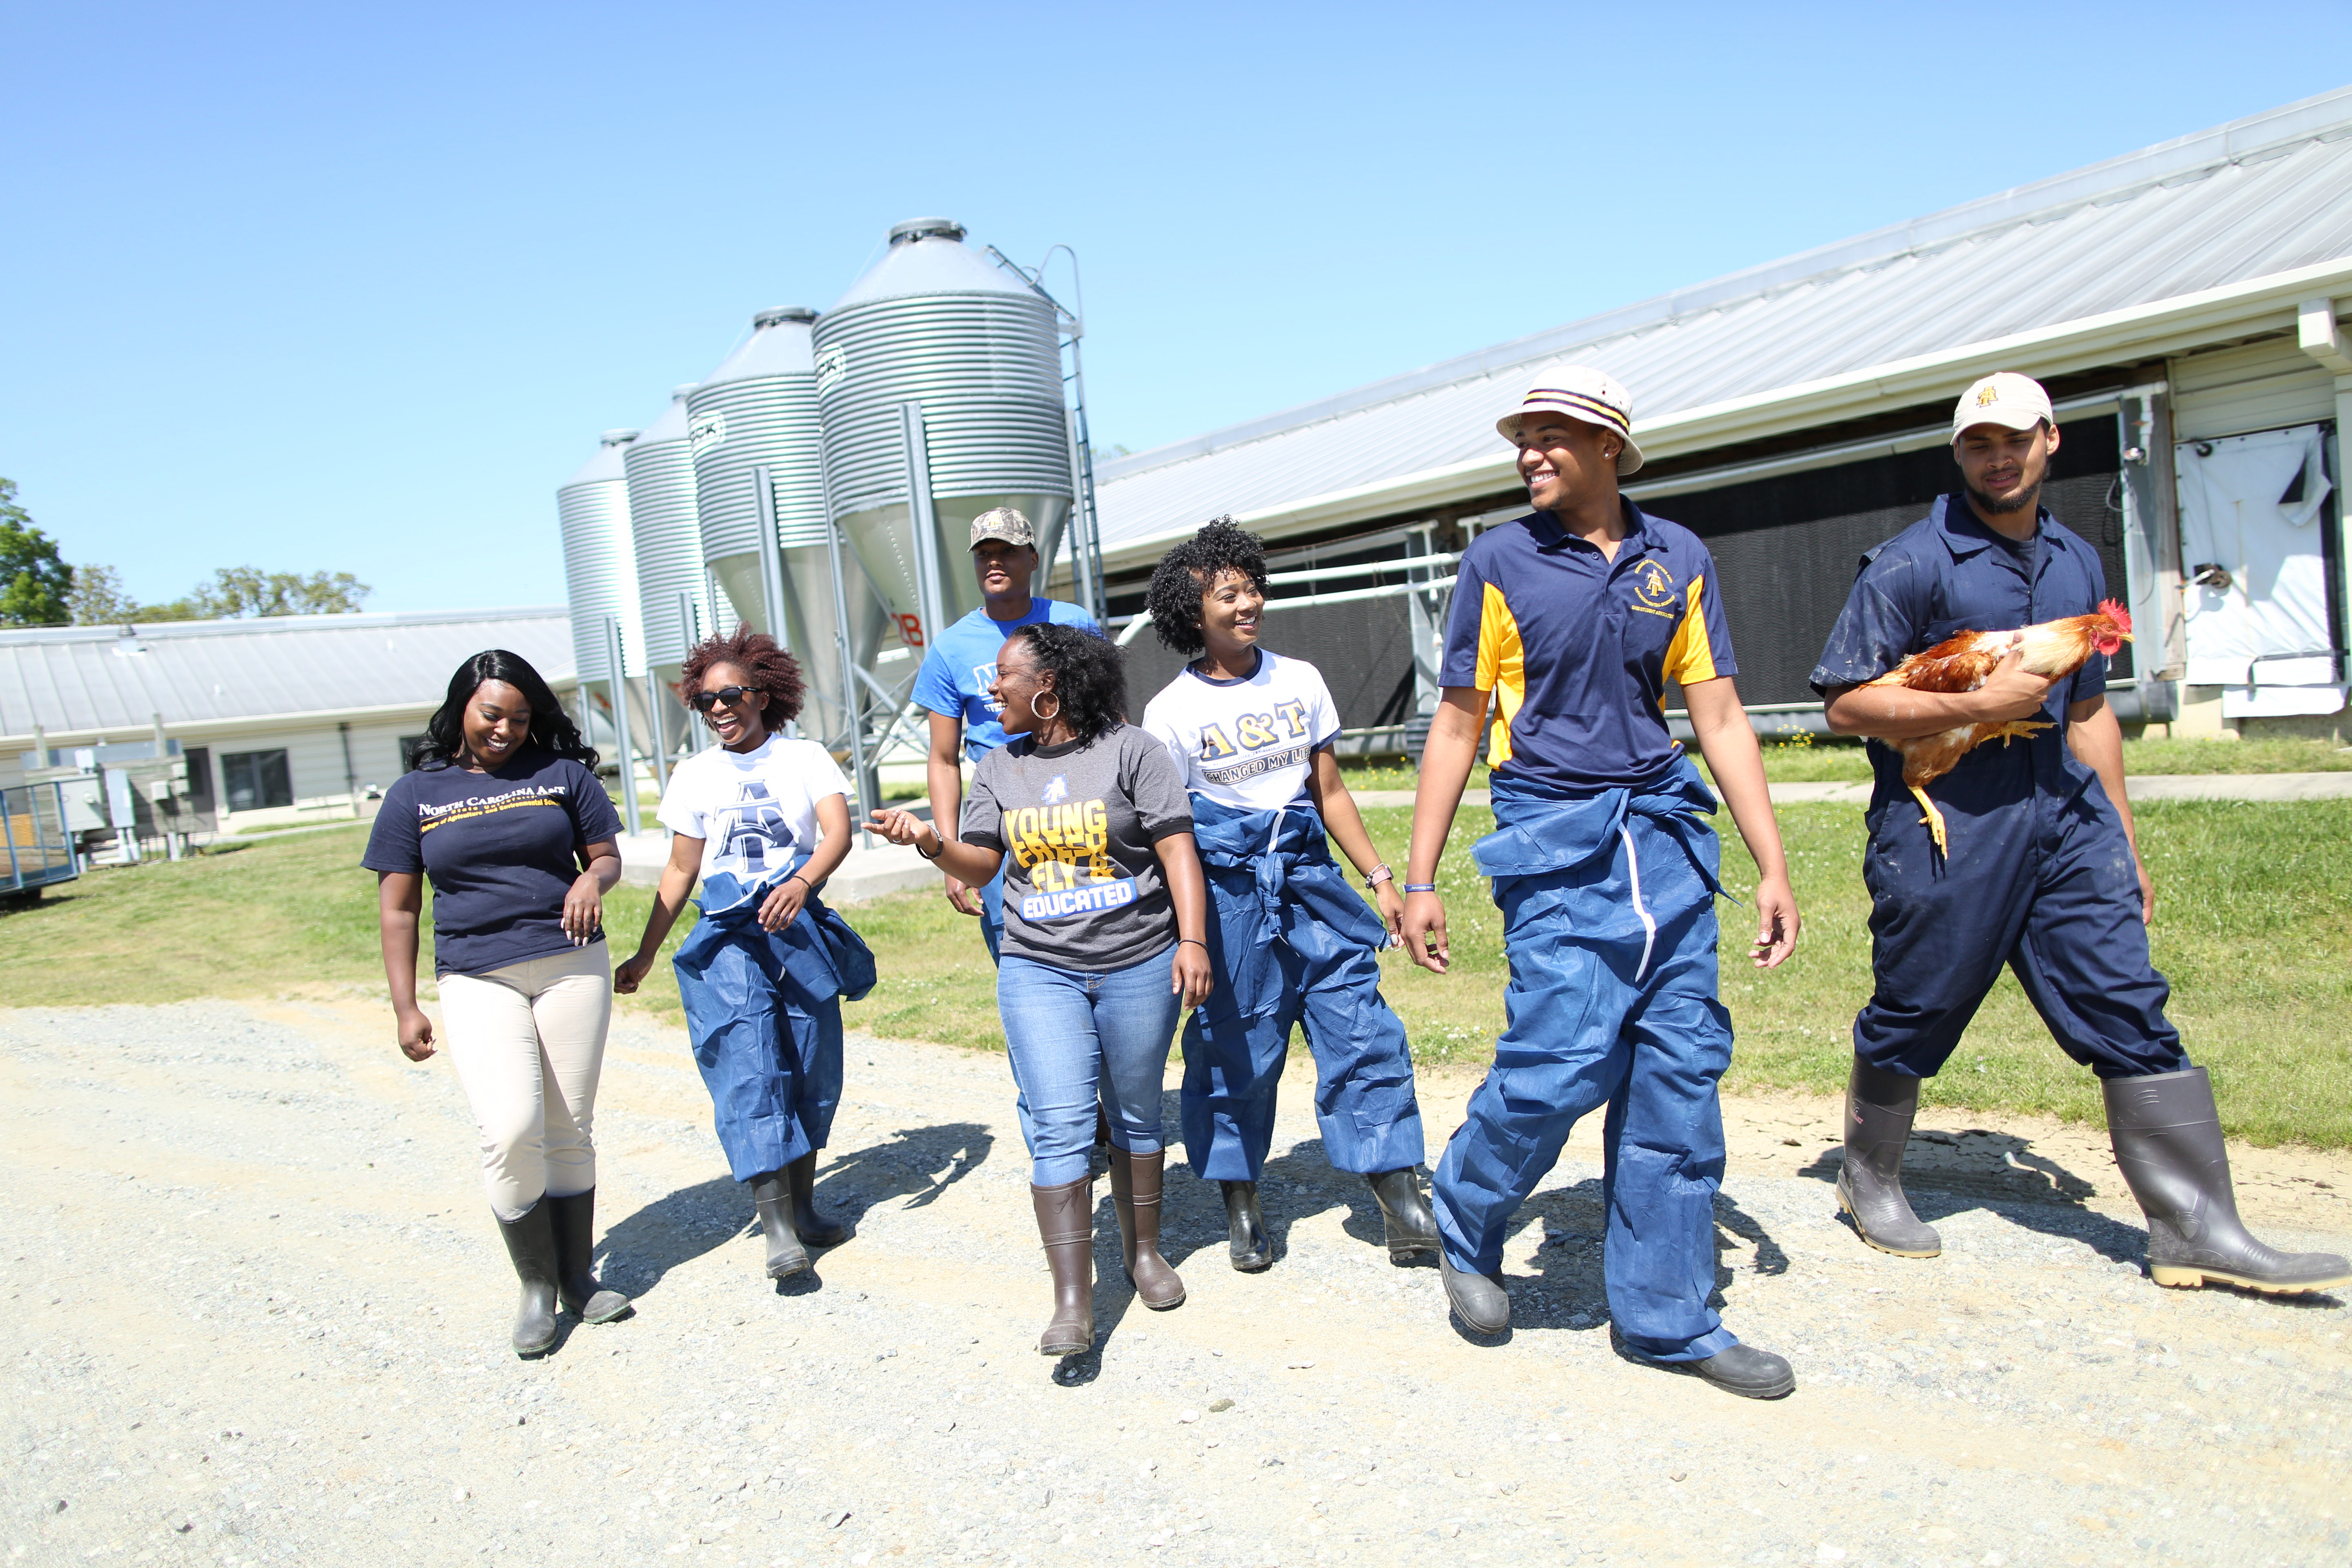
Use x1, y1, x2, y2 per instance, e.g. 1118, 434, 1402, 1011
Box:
814, 218, 1073, 644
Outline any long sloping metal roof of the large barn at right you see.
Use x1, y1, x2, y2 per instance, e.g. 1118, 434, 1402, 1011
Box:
1098, 87, 2352, 557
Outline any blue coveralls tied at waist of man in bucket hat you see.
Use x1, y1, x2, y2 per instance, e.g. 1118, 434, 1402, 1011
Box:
1432, 757, 1738, 1361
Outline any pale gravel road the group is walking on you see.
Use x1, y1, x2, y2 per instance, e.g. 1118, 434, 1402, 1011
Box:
0, 1002, 2352, 1568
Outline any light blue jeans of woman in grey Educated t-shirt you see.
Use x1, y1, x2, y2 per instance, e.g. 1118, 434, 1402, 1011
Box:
997, 947, 1183, 1187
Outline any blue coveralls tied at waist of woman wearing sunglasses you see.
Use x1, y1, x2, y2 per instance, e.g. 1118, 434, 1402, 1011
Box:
675, 858, 875, 1183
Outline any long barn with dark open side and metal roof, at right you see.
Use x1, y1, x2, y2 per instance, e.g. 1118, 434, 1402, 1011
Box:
1098, 87, 2352, 750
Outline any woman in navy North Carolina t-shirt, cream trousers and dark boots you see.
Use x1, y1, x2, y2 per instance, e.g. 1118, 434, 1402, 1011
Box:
362, 649, 630, 1356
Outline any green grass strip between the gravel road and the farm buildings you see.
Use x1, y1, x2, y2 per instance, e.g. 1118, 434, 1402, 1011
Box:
0, 799, 2352, 1147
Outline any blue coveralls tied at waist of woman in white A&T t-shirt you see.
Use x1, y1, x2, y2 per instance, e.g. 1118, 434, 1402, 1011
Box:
1183, 795, 1425, 1183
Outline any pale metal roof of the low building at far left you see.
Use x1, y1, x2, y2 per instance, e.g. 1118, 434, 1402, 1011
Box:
0, 606, 574, 738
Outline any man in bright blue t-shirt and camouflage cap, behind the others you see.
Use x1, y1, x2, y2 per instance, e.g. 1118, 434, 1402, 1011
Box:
915, 506, 1103, 959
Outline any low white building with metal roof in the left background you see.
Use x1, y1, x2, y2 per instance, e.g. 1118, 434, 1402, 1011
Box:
0, 606, 581, 832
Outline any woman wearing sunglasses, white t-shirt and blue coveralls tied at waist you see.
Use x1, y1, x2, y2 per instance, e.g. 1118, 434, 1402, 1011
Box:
612, 628, 875, 1279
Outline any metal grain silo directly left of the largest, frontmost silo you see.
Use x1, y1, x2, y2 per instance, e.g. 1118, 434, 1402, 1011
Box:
687, 305, 884, 740
